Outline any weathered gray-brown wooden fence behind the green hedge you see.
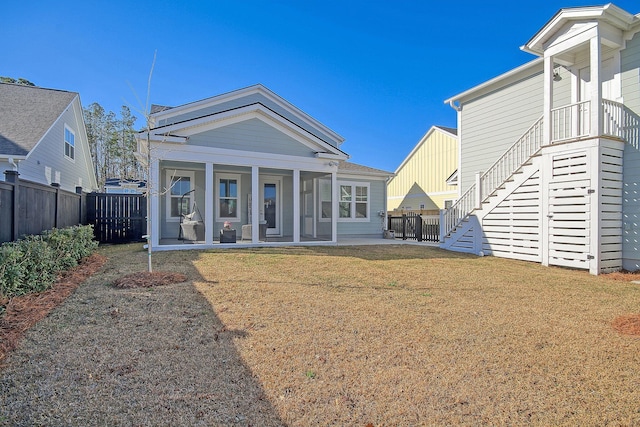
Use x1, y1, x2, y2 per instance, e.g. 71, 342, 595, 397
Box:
0, 171, 86, 243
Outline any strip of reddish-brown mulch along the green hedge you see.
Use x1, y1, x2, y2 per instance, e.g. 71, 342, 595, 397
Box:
0, 253, 107, 363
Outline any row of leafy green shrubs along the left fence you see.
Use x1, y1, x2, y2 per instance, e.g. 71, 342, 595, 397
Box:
0, 226, 98, 298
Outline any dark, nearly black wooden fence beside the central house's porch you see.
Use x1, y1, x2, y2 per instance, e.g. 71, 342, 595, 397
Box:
87, 193, 147, 243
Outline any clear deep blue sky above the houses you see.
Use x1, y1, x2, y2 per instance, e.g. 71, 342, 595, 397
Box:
0, 0, 640, 171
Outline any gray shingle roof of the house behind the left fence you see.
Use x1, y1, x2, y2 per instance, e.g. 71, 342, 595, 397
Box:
0, 83, 78, 156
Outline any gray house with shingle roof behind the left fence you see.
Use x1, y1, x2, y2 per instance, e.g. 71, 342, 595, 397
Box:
0, 83, 97, 192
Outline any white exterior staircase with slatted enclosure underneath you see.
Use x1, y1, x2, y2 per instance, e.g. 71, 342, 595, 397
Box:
440, 100, 637, 274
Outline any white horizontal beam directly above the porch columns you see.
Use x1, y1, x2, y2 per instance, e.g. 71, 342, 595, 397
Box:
151, 142, 340, 172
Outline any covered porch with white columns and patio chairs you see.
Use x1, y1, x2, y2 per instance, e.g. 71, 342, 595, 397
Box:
151, 156, 339, 250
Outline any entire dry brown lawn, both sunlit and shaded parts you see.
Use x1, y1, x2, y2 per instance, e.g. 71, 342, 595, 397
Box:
0, 245, 640, 427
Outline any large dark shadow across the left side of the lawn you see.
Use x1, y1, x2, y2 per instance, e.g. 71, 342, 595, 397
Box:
0, 245, 284, 426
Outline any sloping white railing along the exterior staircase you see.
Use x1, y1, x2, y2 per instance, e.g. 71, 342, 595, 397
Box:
440, 117, 543, 239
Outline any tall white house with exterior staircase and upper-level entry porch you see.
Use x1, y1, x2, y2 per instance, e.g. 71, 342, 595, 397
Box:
441, 4, 640, 274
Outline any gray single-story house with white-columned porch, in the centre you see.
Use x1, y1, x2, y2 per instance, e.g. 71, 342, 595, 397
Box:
137, 85, 393, 250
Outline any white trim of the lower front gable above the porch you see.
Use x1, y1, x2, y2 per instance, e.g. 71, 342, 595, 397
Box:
151, 104, 346, 158
